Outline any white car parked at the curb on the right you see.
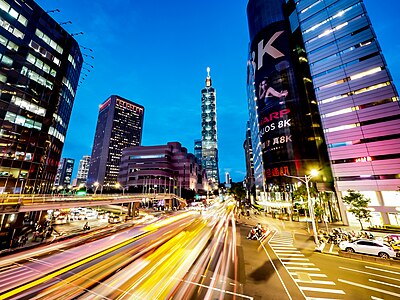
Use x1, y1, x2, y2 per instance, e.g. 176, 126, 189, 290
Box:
339, 240, 396, 259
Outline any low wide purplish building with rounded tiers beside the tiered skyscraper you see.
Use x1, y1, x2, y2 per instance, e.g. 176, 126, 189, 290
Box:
118, 142, 207, 196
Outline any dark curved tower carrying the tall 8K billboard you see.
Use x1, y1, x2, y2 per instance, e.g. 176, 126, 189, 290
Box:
247, 0, 340, 221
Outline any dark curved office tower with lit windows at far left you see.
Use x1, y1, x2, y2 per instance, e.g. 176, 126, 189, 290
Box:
0, 0, 83, 193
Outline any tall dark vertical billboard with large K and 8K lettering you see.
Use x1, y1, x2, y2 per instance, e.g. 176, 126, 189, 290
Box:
249, 21, 305, 182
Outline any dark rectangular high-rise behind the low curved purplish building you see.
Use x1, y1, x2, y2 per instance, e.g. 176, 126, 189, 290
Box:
87, 95, 144, 187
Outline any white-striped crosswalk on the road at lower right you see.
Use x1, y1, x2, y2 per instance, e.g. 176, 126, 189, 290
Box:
268, 232, 345, 300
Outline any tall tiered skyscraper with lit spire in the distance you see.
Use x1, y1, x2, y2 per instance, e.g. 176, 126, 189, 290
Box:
201, 68, 219, 189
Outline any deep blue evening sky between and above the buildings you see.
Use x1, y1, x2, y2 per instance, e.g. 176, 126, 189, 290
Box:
37, 0, 400, 182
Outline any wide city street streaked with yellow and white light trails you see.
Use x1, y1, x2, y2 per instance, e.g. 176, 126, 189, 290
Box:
0, 204, 400, 300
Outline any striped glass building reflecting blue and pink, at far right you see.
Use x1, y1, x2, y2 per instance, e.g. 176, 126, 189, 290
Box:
293, 0, 400, 224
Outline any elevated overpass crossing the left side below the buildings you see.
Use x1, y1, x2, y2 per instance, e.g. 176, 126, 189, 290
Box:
0, 194, 186, 215
